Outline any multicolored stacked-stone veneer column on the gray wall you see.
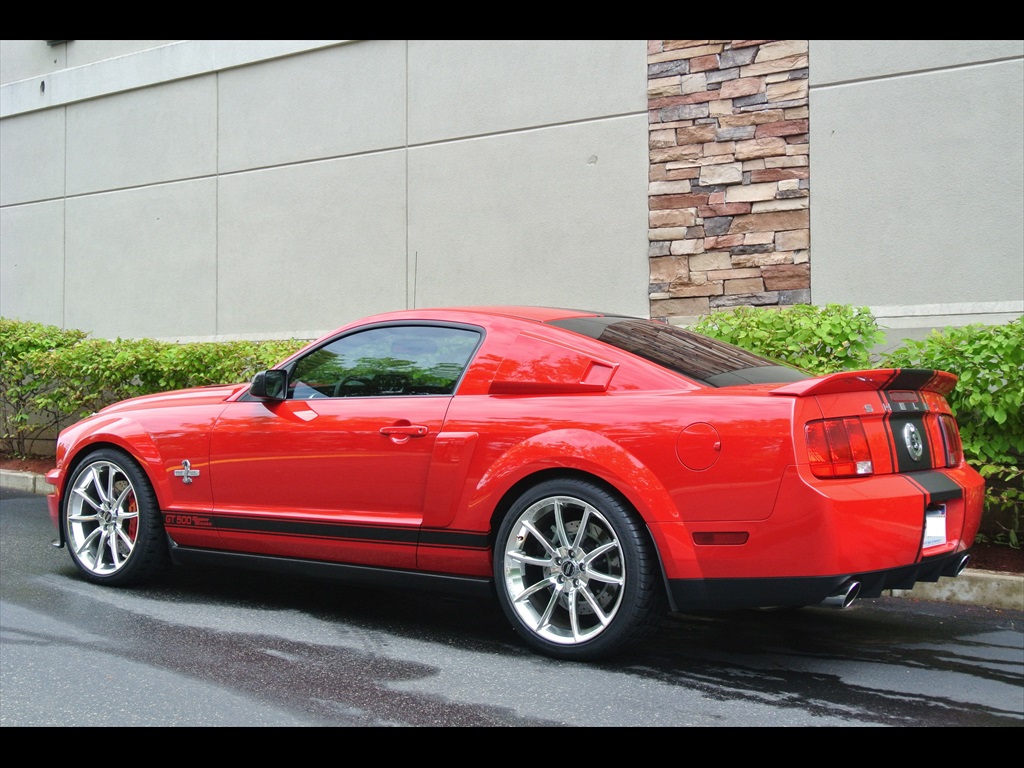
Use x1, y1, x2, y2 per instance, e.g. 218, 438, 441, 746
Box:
647, 40, 811, 324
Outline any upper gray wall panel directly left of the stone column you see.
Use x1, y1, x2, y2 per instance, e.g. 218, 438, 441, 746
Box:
409, 40, 647, 144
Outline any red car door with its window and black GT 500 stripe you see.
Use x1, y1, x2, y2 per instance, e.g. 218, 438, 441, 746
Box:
210, 325, 479, 567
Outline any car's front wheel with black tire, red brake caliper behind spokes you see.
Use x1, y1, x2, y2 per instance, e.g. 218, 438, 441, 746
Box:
61, 449, 170, 587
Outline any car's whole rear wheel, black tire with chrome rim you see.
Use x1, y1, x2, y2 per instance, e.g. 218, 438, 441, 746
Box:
494, 479, 667, 660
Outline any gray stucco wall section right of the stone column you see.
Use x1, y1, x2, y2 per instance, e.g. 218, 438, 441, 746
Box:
809, 40, 1024, 340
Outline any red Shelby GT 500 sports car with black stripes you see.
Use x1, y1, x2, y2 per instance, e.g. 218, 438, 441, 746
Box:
47, 307, 984, 659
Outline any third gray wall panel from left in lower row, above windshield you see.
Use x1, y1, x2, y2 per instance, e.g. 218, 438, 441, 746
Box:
217, 152, 407, 338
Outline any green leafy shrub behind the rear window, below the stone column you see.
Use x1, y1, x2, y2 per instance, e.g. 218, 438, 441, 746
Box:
693, 304, 884, 375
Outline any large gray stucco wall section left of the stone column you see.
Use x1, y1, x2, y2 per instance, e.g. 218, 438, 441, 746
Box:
0, 41, 647, 340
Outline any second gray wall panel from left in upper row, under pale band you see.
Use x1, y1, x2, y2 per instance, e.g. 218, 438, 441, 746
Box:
67, 75, 217, 195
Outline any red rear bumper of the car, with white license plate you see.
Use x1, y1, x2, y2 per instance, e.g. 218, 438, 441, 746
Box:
650, 465, 984, 589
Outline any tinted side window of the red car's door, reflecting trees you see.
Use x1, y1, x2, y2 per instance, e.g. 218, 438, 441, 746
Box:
288, 326, 480, 399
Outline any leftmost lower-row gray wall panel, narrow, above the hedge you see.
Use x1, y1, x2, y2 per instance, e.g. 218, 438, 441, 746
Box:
0, 201, 65, 326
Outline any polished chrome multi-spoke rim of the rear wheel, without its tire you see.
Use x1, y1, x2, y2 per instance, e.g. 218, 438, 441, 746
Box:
504, 496, 627, 645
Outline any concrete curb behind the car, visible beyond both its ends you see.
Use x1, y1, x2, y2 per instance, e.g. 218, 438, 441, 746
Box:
0, 469, 1024, 611
